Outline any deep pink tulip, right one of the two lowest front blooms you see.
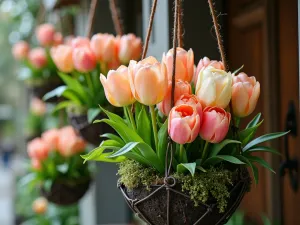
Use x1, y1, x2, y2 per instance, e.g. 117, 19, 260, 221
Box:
200, 107, 231, 143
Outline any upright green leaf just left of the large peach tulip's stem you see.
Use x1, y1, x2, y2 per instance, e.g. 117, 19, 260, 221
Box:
136, 107, 152, 146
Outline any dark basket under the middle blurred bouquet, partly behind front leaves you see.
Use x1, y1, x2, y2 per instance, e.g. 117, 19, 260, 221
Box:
69, 114, 114, 146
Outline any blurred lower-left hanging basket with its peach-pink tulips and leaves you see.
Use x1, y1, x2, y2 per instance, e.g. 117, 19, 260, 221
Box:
27, 126, 90, 205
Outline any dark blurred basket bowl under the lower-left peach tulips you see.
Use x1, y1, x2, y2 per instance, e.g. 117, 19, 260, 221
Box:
41, 178, 91, 206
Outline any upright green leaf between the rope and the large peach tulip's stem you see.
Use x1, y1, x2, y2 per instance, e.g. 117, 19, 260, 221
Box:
156, 119, 168, 163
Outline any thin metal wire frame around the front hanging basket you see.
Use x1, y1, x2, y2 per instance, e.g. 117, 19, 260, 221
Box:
118, 168, 251, 225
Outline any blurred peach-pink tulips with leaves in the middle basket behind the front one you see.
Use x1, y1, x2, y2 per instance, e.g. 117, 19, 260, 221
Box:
44, 33, 142, 122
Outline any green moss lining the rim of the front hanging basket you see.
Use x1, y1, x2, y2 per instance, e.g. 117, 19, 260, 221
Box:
118, 160, 234, 213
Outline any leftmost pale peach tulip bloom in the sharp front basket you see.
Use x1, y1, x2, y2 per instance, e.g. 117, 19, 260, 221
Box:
100, 66, 135, 107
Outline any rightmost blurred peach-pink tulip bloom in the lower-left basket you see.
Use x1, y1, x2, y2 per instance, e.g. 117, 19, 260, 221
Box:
58, 126, 86, 157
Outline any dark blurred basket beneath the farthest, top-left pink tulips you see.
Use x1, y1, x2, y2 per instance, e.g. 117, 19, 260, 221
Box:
28, 79, 63, 103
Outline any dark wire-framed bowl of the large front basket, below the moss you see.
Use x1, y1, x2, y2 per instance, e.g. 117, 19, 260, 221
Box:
118, 168, 251, 225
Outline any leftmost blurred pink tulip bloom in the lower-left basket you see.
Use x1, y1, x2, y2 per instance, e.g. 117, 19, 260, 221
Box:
27, 138, 50, 161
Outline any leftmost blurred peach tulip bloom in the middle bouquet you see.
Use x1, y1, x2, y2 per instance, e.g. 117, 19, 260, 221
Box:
50, 45, 74, 73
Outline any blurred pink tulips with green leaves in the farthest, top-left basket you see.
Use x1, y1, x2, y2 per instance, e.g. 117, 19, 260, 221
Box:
12, 24, 63, 86
